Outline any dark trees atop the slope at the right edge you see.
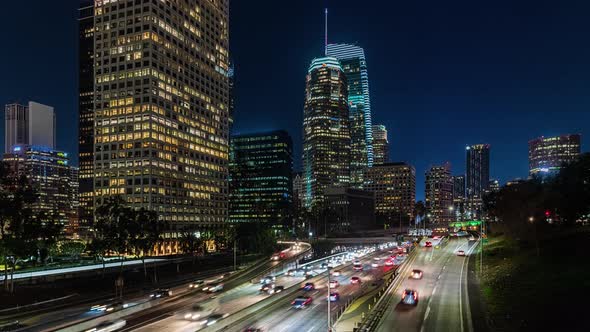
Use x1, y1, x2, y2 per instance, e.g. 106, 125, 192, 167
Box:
484, 153, 590, 253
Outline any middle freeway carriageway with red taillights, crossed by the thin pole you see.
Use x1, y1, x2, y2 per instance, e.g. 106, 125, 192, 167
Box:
227, 251, 400, 332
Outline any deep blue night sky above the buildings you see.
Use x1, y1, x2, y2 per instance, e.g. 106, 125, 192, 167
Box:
0, 0, 590, 199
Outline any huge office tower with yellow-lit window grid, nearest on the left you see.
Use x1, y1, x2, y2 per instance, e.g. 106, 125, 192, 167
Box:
94, 0, 229, 235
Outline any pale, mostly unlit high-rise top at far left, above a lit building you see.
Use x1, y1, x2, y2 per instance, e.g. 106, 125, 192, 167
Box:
4, 101, 55, 153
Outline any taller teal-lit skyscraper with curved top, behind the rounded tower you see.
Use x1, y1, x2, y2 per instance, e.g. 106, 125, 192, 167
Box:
326, 44, 374, 187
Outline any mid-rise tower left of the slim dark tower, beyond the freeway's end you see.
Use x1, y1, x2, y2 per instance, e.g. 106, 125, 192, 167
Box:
424, 164, 455, 223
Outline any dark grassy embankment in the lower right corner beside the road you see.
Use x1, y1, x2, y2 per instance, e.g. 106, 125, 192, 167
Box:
476, 228, 590, 331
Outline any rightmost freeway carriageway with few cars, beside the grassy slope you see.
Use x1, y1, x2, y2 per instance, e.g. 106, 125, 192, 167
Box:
377, 238, 476, 332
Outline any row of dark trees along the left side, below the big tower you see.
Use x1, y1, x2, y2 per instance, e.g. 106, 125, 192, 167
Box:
0, 158, 276, 292
